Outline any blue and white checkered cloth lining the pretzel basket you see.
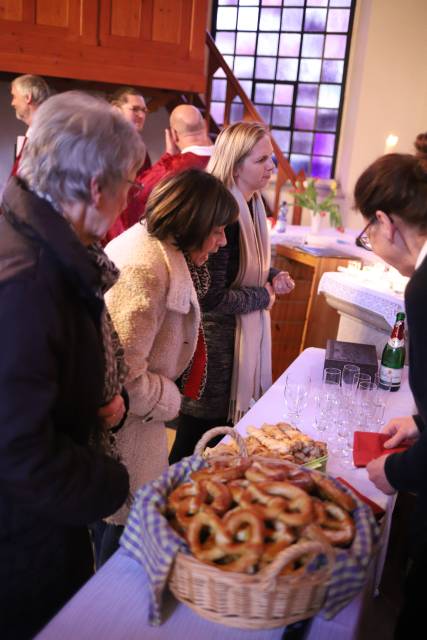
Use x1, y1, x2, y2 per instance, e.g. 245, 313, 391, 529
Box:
120, 455, 380, 625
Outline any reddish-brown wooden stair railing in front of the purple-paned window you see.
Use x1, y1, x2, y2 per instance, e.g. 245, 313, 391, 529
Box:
205, 32, 305, 224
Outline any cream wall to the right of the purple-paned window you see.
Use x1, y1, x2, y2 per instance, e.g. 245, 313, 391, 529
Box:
336, 0, 427, 228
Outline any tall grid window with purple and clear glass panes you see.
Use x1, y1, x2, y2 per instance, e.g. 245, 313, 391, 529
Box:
212, 0, 355, 179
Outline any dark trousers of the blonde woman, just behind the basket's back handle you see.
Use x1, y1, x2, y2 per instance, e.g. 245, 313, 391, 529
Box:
169, 413, 232, 464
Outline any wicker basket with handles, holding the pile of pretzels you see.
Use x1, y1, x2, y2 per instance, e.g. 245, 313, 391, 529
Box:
169, 427, 335, 629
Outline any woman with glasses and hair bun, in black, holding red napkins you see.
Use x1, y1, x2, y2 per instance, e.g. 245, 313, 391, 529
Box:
355, 134, 427, 638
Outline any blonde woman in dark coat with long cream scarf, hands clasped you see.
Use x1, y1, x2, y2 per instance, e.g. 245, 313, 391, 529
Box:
170, 122, 294, 462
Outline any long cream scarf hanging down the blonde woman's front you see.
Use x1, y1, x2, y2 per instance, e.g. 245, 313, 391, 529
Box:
228, 186, 272, 424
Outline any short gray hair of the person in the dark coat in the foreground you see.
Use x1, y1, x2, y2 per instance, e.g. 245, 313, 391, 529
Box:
18, 91, 145, 209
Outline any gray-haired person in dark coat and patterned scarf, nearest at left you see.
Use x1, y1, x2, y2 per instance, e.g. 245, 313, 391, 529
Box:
0, 92, 145, 640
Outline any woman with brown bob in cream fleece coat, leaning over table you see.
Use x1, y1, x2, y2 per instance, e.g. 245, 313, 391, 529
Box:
100, 169, 241, 562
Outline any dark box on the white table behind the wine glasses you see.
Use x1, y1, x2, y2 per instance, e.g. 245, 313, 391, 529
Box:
324, 340, 378, 381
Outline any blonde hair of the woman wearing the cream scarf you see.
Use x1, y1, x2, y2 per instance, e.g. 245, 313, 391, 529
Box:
206, 122, 270, 189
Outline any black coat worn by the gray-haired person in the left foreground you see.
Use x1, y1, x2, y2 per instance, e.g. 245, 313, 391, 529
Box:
0, 178, 128, 640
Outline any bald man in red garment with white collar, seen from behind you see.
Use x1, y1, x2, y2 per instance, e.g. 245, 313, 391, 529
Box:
109, 104, 213, 240
